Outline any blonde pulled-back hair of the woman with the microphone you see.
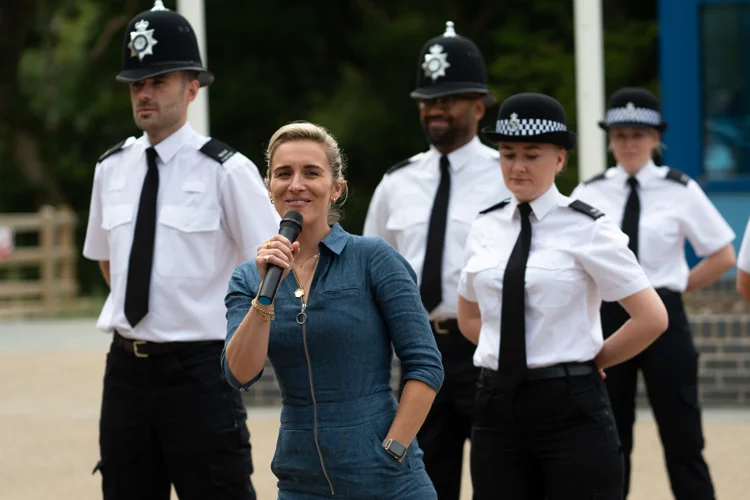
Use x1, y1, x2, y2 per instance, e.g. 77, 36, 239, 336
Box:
265, 121, 349, 224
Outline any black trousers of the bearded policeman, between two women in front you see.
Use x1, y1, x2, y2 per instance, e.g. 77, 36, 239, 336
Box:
402, 328, 479, 500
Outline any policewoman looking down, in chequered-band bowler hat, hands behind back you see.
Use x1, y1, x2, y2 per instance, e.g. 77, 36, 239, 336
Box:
458, 94, 667, 500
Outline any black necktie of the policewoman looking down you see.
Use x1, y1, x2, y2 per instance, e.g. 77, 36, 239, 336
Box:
498, 203, 531, 387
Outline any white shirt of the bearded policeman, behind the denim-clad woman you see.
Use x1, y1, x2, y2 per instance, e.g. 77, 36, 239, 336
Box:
363, 136, 510, 319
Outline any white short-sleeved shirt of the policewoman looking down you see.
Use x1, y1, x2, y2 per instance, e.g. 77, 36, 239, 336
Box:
458, 185, 649, 370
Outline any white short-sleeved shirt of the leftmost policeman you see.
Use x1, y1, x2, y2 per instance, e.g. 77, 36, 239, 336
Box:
83, 123, 279, 342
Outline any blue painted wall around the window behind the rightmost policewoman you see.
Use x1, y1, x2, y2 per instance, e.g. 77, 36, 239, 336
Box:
659, 0, 750, 272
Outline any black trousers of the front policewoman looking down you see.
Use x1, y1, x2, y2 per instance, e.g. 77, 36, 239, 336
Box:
471, 369, 623, 500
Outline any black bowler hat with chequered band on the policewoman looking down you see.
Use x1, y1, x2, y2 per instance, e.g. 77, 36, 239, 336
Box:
482, 94, 576, 150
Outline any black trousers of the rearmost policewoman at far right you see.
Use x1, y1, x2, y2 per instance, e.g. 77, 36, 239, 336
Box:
601, 289, 714, 500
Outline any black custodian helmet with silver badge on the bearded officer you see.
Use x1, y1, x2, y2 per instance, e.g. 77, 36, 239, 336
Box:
411, 21, 494, 100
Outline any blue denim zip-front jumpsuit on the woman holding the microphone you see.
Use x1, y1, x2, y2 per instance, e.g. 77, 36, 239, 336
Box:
221, 224, 443, 500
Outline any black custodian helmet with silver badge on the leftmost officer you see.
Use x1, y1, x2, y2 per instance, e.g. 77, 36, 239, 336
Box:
117, 0, 214, 87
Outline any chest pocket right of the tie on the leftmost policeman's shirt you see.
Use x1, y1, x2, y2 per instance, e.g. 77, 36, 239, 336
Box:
154, 205, 221, 278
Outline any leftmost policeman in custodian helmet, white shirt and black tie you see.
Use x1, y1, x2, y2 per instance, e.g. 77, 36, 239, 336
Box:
83, 1, 278, 500
